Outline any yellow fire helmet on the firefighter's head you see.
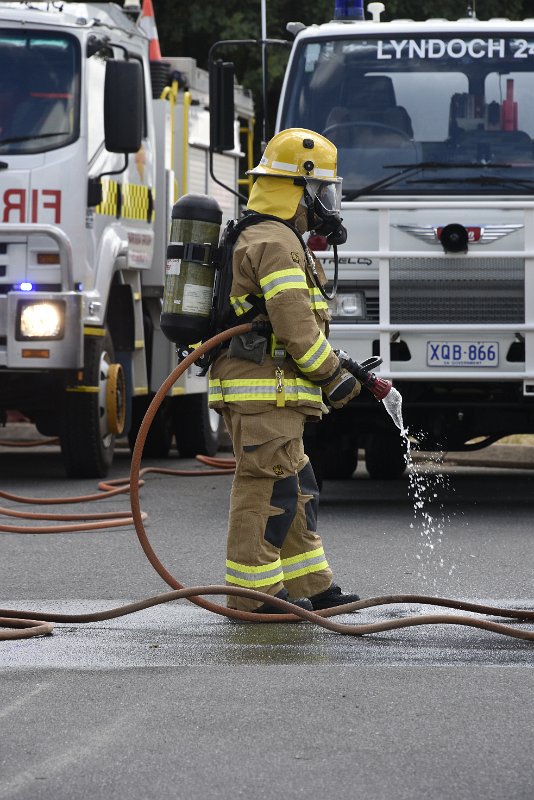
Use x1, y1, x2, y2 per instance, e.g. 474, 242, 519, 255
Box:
247, 128, 341, 183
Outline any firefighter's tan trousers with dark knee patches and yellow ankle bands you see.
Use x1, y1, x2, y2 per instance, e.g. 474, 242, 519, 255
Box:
222, 406, 332, 611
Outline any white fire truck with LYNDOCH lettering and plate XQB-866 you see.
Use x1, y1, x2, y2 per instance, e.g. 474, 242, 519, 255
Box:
276, 0, 534, 478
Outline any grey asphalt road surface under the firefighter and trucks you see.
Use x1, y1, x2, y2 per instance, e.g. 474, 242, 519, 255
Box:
0, 448, 534, 800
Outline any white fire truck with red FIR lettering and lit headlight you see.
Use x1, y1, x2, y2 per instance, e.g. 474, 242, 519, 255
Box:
0, 0, 253, 477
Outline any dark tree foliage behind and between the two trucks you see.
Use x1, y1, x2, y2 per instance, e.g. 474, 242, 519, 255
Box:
154, 0, 534, 161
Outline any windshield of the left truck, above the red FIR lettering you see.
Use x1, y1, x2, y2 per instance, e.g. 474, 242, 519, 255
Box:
0, 29, 80, 154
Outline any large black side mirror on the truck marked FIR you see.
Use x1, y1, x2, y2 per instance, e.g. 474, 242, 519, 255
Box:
104, 59, 144, 153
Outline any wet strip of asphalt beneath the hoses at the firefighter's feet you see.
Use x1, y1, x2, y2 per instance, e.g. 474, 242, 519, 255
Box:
0, 598, 534, 670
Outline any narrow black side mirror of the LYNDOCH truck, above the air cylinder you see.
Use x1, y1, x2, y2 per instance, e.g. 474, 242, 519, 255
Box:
209, 60, 235, 153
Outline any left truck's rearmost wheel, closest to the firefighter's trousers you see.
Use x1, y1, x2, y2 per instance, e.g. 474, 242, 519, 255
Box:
171, 392, 221, 458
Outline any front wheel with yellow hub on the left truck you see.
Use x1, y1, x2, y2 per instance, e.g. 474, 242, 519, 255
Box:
60, 333, 121, 478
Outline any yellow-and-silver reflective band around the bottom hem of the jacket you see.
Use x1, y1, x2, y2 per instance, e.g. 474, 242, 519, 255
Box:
208, 378, 322, 405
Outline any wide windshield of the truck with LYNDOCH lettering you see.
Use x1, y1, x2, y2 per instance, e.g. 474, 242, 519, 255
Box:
280, 34, 534, 200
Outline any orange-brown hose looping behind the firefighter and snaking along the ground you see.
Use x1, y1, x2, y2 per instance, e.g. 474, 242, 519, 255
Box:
0, 324, 534, 641
